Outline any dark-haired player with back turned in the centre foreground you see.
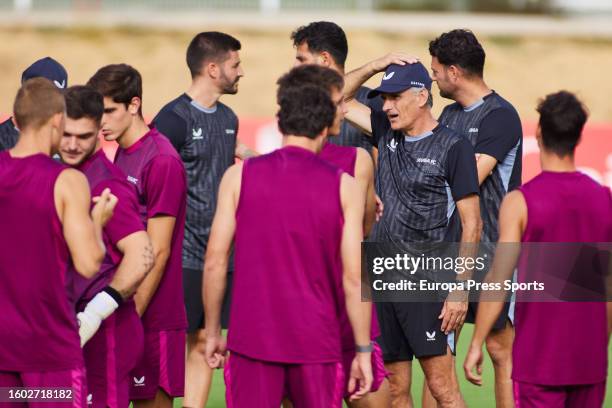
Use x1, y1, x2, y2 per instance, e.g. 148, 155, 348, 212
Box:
204, 67, 372, 408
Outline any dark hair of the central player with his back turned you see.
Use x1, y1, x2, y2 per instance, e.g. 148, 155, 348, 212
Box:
276, 65, 336, 139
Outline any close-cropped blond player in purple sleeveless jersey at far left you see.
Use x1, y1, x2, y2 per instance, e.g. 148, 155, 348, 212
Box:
0, 78, 117, 406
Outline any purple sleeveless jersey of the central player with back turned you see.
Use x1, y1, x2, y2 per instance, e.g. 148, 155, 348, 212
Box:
228, 146, 344, 364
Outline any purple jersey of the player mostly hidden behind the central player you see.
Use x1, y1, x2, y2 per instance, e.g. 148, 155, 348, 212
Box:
319, 143, 380, 350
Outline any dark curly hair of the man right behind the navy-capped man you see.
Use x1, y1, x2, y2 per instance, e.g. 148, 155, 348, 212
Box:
429, 29, 485, 78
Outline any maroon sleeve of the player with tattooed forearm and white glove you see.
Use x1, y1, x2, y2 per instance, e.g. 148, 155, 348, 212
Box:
93, 180, 145, 245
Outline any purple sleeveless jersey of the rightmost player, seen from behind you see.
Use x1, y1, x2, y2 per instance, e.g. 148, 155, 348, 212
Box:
512, 172, 612, 386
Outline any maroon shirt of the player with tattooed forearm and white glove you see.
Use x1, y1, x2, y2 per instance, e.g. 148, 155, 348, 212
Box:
67, 149, 145, 309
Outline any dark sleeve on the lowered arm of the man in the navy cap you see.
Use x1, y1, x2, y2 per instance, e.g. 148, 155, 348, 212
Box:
446, 138, 479, 201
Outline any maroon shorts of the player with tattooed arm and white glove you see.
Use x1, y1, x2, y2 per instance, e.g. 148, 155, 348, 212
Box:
83, 302, 144, 408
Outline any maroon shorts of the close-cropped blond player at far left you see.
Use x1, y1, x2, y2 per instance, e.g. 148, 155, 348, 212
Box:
0, 367, 87, 408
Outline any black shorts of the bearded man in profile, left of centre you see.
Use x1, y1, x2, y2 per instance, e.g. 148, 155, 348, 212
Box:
183, 268, 234, 333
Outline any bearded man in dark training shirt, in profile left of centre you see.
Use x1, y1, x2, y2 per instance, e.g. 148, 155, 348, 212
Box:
153, 31, 256, 407
